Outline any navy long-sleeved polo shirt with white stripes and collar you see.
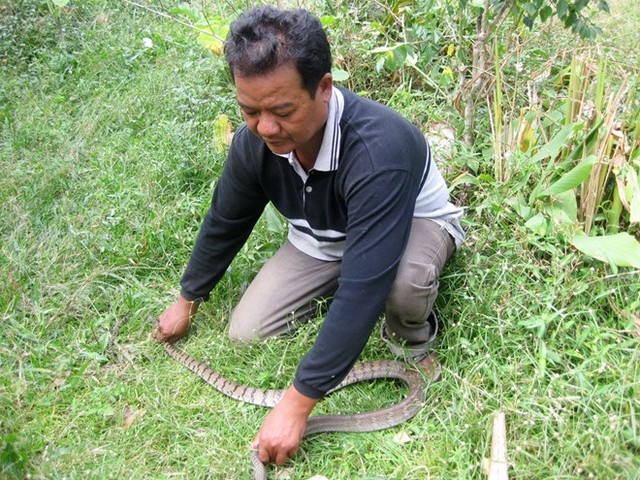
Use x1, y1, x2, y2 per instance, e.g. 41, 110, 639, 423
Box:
182, 87, 463, 398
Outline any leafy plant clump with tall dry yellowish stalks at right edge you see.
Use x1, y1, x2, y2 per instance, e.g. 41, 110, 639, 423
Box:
500, 57, 640, 268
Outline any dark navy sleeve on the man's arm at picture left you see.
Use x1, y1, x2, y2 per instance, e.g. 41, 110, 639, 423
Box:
180, 129, 267, 301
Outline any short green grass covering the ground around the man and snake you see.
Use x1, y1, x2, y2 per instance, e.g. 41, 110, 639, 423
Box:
0, 0, 640, 480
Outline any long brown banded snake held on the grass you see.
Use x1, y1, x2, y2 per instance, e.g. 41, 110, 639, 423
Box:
163, 342, 438, 480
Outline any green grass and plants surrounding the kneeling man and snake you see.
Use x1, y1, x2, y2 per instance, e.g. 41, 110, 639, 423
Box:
0, 0, 640, 479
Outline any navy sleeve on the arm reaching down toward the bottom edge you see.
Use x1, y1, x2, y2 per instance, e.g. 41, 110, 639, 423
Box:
294, 170, 420, 398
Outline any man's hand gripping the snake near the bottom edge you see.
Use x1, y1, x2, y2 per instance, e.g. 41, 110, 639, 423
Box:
253, 385, 318, 465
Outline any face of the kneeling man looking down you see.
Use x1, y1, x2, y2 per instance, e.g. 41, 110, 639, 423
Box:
235, 64, 332, 160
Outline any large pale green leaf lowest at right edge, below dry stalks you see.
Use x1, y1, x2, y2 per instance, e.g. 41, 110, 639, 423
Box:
571, 231, 640, 268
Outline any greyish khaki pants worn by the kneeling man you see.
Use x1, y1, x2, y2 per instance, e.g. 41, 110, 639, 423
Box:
229, 218, 455, 343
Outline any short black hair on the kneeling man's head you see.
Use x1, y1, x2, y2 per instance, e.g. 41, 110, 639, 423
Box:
224, 6, 331, 98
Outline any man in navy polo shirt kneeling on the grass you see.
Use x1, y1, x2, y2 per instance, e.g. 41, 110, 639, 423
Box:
155, 7, 463, 464
